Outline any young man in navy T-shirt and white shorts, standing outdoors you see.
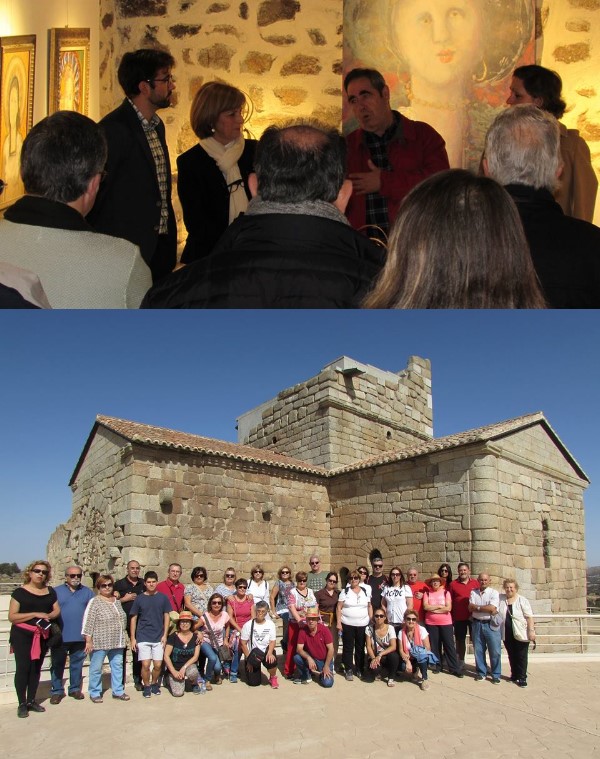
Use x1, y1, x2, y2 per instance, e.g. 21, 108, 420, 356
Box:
129, 565, 171, 698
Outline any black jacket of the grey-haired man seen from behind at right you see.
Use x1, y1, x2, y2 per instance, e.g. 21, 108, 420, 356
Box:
506, 185, 600, 308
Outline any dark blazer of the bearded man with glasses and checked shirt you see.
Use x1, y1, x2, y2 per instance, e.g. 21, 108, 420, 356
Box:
87, 98, 177, 281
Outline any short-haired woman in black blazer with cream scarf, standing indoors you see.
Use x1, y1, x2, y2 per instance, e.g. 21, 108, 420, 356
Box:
177, 82, 256, 264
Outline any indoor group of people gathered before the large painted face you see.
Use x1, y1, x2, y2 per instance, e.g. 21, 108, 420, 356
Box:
0, 44, 600, 308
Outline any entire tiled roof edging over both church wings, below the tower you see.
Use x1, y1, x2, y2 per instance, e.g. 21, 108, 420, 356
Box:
69, 412, 589, 484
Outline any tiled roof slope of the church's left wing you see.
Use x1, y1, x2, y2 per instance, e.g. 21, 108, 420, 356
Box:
96, 415, 327, 475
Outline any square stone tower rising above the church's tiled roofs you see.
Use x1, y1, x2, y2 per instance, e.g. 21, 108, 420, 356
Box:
238, 356, 433, 469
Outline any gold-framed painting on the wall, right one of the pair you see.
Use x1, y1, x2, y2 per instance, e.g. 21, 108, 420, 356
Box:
48, 27, 90, 116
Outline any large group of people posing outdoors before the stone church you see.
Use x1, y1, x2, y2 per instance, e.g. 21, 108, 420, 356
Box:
9, 556, 535, 717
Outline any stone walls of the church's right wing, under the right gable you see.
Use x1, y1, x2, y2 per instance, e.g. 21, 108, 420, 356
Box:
330, 428, 586, 613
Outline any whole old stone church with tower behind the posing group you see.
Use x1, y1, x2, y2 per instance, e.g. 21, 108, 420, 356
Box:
48, 356, 589, 613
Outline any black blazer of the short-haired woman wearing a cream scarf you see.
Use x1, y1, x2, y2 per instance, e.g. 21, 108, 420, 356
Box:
177, 140, 256, 264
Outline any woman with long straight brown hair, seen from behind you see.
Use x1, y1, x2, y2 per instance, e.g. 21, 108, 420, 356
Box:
363, 169, 545, 308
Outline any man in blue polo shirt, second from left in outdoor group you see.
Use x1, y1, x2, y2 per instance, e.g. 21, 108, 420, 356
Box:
50, 566, 94, 705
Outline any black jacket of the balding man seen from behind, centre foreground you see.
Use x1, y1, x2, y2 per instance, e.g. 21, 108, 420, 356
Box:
142, 213, 384, 308
